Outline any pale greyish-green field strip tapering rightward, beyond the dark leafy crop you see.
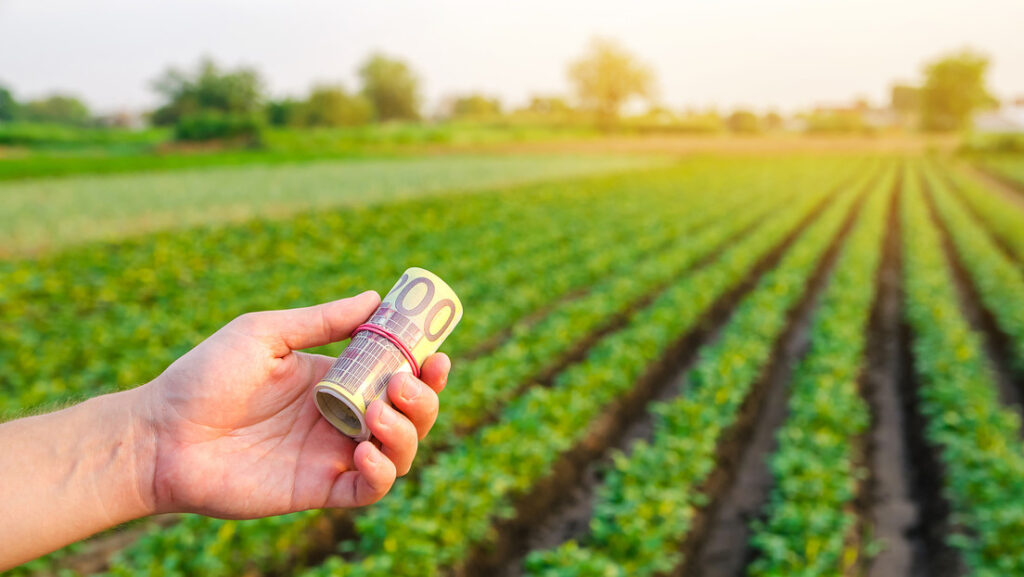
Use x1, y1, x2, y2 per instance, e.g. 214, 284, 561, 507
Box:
0, 155, 670, 256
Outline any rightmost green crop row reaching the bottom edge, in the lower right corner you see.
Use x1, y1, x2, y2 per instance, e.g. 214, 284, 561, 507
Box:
902, 165, 1024, 577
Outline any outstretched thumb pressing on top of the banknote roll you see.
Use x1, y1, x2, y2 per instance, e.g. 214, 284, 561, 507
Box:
242, 290, 381, 357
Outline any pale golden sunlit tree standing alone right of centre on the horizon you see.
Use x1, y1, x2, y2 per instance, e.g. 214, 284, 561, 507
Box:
568, 38, 654, 125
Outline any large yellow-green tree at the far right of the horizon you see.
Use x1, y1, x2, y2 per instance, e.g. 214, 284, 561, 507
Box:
921, 49, 995, 131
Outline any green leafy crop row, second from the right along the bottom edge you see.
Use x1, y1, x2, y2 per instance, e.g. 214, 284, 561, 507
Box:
750, 166, 892, 577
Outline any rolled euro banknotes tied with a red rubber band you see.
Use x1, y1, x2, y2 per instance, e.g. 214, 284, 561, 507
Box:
313, 266, 462, 441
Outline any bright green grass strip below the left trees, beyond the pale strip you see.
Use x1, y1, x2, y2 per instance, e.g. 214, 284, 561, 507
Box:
0, 123, 596, 180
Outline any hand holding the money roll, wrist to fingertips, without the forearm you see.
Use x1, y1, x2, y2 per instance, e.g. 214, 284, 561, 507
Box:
131, 292, 451, 519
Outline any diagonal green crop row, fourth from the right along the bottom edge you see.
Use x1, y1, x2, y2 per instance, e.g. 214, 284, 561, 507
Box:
310, 163, 864, 577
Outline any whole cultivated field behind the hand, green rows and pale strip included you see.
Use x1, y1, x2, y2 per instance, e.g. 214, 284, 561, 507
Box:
6, 151, 1024, 577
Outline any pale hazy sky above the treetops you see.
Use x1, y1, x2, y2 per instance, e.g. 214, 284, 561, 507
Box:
0, 0, 1024, 112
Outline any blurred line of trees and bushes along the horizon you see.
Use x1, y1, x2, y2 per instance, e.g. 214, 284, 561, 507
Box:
0, 38, 997, 142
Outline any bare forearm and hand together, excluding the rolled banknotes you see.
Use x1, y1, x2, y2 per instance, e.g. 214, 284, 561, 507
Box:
0, 292, 451, 571
